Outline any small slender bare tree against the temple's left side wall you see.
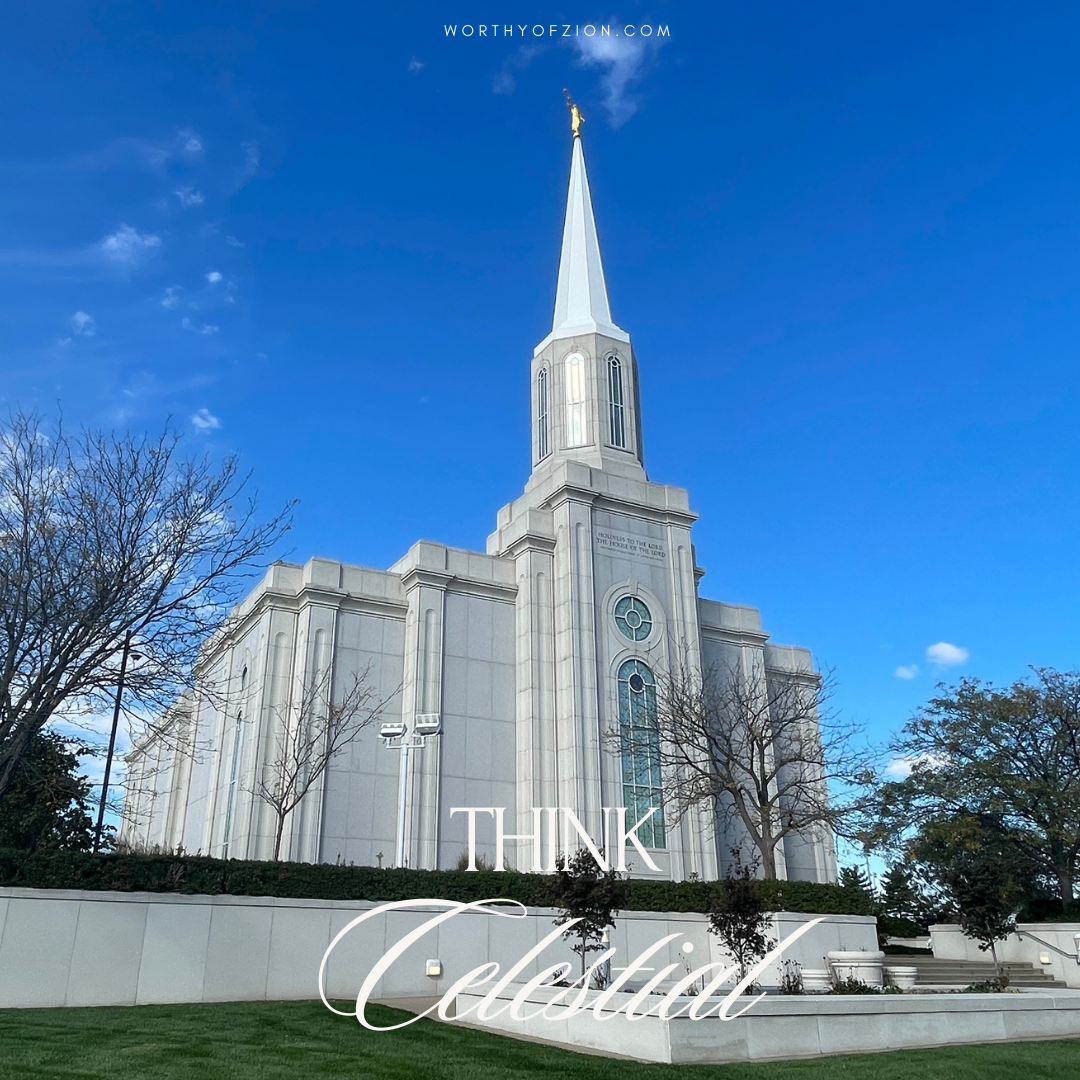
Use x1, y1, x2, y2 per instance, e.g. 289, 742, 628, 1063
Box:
253, 667, 397, 860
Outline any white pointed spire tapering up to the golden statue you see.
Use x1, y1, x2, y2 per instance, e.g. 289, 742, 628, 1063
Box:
548, 132, 630, 341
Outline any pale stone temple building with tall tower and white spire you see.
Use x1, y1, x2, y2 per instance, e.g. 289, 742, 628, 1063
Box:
122, 128, 836, 881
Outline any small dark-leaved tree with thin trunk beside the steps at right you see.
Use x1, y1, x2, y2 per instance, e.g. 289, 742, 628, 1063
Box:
910, 814, 1031, 988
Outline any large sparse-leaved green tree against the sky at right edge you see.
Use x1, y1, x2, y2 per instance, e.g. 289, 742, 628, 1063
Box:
874, 667, 1080, 903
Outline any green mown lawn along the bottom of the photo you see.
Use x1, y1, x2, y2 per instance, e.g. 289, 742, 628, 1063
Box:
0, 1001, 1080, 1080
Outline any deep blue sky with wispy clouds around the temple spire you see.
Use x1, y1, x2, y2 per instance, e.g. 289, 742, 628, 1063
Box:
0, 0, 1080, 790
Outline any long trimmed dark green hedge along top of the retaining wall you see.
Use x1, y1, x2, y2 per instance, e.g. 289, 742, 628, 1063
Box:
0, 849, 874, 915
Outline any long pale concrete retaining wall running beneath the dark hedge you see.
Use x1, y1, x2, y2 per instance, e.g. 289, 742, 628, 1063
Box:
0, 888, 877, 1008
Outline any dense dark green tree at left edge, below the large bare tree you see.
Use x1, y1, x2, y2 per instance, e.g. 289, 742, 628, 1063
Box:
0, 731, 94, 851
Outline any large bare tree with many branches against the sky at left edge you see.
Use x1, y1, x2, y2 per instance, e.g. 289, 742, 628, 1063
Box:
0, 414, 289, 796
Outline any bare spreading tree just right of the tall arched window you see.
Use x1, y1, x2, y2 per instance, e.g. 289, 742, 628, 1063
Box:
619, 665, 873, 878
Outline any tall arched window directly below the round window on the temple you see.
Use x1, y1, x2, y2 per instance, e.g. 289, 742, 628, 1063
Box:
618, 660, 665, 848
